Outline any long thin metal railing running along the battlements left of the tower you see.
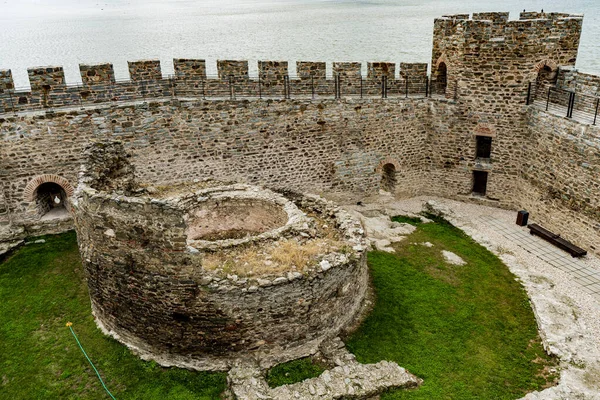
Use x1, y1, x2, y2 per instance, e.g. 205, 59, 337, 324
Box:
0, 75, 446, 114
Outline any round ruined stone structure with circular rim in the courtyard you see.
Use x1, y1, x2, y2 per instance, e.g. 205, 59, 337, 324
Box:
72, 143, 368, 370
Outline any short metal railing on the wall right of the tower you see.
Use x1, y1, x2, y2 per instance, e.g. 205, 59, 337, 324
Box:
527, 82, 600, 125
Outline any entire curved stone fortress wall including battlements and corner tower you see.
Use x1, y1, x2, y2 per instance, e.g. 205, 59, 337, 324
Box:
0, 13, 600, 253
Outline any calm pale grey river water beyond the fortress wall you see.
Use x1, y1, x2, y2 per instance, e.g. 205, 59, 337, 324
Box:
0, 0, 600, 87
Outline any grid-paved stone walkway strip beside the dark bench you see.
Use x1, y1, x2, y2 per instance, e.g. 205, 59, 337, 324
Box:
477, 214, 600, 301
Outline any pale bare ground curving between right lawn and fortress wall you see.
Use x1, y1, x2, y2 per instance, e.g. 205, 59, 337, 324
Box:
338, 194, 600, 400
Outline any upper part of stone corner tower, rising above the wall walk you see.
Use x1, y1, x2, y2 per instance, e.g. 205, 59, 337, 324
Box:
431, 12, 583, 101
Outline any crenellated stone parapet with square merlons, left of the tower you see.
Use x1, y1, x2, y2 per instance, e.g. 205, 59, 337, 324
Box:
0, 58, 429, 114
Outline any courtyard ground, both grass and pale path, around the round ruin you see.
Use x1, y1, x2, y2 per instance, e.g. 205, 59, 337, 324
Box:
0, 197, 600, 399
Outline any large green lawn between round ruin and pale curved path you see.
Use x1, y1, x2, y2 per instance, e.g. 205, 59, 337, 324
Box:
346, 220, 556, 400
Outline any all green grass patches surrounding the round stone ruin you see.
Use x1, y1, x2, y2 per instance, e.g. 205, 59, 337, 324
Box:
0, 220, 555, 400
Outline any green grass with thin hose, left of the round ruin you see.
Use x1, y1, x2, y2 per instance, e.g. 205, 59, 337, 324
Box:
0, 232, 226, 400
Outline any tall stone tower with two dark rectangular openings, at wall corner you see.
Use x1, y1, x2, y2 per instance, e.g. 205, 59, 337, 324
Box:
431, 12, 583, 202
